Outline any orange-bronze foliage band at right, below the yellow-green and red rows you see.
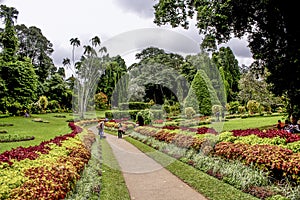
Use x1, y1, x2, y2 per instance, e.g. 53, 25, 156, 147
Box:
215, 142, 300, 182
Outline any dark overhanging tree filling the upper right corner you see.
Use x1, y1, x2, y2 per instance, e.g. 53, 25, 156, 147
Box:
154, 0, 300, 115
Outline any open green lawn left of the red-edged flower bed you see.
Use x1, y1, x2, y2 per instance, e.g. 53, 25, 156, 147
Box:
0, 113, 73, 153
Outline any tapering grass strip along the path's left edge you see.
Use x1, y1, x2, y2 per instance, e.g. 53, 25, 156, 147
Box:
100, 136, 130, 200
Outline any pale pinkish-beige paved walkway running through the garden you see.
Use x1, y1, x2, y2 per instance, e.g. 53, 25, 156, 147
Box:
92, 128, 206, 200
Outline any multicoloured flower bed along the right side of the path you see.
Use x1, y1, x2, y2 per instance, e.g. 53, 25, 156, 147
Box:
130, 126, 300, 199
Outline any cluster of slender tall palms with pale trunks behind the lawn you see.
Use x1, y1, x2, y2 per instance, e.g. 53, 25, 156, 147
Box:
67, 36, 108, 118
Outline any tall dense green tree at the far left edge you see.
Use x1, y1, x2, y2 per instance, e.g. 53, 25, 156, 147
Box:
0, 5, 37, 114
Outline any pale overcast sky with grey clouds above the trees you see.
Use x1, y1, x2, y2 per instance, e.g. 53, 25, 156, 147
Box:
0, 0, 252, 66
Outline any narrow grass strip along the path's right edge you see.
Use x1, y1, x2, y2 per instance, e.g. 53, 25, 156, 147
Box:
125, 137, 258, 200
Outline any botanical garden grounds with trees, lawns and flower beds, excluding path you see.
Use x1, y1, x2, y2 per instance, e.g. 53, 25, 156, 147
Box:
0, 0, 300, 200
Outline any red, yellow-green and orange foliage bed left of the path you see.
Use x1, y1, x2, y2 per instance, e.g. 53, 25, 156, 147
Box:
0, 122, 95, 200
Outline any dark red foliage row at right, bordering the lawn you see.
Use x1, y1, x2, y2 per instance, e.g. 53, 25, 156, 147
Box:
231, 129, 300, 143
